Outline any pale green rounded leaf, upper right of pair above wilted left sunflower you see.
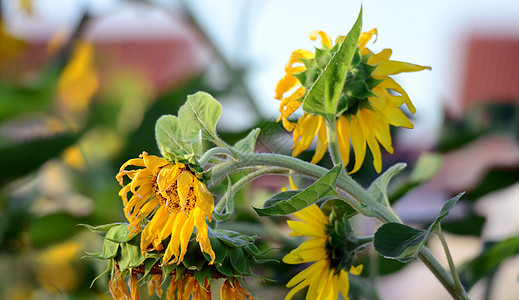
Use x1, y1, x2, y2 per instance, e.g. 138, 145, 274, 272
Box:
178, 92, 222, 142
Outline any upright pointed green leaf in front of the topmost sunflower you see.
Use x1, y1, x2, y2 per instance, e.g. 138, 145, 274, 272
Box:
303, 8, 362, 122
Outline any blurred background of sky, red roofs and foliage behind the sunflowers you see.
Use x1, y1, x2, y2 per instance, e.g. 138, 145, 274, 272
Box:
0, 0, 519, 300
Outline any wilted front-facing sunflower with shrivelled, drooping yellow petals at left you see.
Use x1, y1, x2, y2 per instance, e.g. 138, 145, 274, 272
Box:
116, 152, 215, 264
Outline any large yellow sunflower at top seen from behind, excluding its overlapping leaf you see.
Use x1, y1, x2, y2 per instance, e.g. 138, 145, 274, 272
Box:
275, 29, 430, 172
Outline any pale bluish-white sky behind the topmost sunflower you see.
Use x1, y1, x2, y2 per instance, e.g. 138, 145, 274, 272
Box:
4, 0, 519, 149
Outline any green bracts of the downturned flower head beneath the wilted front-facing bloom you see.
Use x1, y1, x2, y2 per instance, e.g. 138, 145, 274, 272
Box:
85, 223, 268, 285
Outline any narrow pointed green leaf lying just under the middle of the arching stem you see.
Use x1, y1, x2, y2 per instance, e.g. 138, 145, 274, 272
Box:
253, 164, 343, 216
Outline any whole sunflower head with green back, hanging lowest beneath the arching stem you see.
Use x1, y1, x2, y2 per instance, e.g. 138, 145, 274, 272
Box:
283, 204, 362, 299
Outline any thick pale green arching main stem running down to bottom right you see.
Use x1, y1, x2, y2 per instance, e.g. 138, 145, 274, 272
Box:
212, 153, 469, 300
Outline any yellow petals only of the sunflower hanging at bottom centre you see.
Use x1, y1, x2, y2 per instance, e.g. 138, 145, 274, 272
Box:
283, 204, 362, 300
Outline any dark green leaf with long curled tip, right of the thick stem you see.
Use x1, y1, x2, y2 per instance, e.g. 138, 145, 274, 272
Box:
373, 193, 463, 263
